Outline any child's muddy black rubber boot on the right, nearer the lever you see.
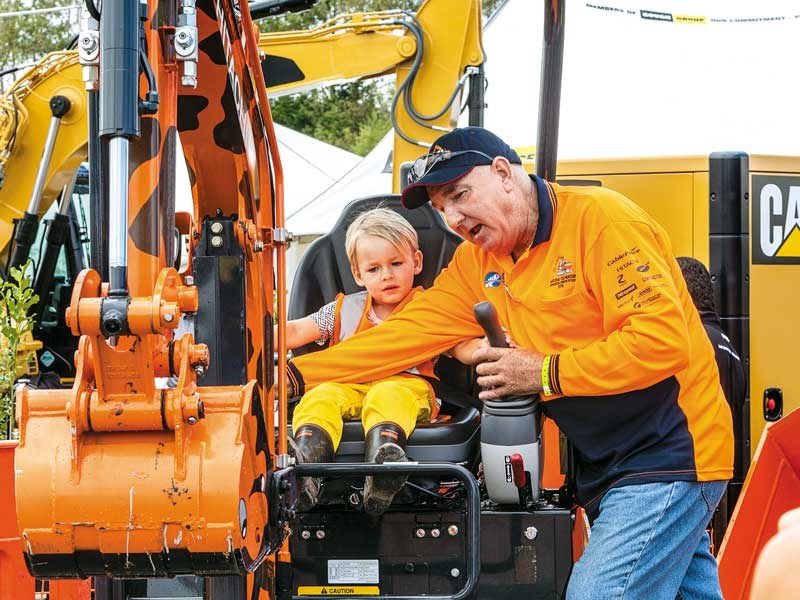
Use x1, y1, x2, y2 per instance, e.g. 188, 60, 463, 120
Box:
364, 423, 408, 515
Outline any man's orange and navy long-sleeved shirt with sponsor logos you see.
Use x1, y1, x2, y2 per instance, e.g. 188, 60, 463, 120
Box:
289, 177, 733, 515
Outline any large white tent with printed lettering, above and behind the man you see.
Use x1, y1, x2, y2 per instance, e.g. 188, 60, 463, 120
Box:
476, 0, 800, 158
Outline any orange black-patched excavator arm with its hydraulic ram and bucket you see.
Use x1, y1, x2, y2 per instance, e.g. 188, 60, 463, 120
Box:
16, 0, 292, 578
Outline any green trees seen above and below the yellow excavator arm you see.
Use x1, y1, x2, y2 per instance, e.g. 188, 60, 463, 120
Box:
259, 0, 503, 156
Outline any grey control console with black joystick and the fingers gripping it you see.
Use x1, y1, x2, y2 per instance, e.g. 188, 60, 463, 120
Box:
474, 302, 541, 506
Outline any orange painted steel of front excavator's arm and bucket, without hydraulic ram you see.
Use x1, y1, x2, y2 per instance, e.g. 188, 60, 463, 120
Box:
11, 0, 286, 580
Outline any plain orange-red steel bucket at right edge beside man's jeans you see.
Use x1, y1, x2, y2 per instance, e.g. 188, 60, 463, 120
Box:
718, 410, 800, 600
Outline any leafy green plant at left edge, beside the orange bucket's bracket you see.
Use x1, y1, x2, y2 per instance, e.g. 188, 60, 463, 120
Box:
0, 261, 39, 439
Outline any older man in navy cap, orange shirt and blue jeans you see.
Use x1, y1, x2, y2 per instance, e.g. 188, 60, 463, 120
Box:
290, 127, 733, 599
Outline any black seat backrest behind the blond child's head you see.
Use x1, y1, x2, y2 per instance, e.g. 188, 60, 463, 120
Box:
288, 194, 474, 394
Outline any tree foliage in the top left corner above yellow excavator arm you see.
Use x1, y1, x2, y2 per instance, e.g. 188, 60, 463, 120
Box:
0, 0, 78, 88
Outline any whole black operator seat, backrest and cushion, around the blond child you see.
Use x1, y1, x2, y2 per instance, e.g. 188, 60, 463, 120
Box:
288, 195, 480, 464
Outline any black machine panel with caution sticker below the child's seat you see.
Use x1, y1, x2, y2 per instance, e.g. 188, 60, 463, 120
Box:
290, 509, 572, 600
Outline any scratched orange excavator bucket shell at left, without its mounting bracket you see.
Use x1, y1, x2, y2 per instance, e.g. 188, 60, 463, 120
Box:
16, 383, 268, 578
